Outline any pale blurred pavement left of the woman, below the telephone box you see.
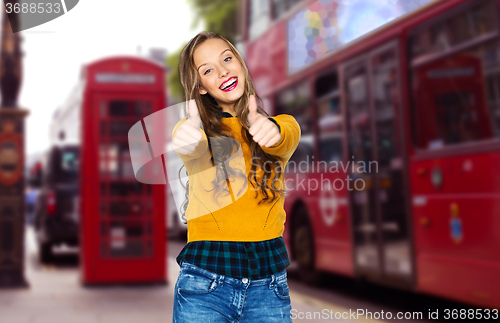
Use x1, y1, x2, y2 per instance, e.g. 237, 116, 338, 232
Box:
0, 228, 179, 323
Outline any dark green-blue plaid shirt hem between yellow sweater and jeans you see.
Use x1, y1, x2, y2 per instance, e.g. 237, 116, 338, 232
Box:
176, 237, 290, 279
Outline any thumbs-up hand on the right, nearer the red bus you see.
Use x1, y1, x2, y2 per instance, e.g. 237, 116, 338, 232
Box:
248, 95, 281, 147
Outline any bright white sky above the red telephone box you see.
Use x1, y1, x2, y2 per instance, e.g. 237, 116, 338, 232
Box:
3, 0, 202, 155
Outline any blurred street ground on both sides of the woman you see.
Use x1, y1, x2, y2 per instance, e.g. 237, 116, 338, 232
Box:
0, 227, 464, 323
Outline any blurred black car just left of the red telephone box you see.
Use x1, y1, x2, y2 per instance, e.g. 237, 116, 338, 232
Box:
34, 145, 80, 262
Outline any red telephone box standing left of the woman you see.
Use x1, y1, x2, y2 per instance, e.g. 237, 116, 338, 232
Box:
80, 56, 167, 284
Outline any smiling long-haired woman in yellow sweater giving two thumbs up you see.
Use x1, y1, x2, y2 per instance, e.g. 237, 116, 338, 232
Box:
172, 32, 301, 323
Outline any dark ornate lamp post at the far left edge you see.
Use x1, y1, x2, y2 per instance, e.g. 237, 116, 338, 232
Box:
0, 0, 28, 288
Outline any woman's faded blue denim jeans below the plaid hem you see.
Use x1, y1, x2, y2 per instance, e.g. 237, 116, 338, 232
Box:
173, 260, 292, 323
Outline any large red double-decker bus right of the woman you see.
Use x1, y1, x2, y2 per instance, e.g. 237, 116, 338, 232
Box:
242, 0, 500, 308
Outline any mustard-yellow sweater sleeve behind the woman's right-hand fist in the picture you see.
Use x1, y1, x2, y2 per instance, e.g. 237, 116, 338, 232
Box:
261, 114, 302, 161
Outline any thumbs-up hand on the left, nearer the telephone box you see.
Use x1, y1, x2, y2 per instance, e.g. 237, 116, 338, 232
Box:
172, 100, 203, 155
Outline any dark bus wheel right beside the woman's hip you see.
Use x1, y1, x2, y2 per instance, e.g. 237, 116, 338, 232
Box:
293, 207, 321, 285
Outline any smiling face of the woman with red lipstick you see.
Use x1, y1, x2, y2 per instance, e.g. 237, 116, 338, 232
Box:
193, 38, 246, 113
